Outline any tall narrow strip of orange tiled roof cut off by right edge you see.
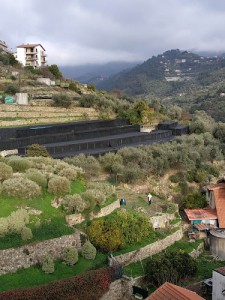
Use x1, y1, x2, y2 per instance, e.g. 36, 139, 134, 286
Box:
213, 188, 225, 228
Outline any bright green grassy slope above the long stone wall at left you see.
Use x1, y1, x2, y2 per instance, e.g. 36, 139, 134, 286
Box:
0, 181, 85, 249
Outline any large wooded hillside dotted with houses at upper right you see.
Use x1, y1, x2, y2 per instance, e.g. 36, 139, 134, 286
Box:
97, 49, 225, 122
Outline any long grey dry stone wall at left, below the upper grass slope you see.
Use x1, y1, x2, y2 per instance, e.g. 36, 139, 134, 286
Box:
0, 231, 81, 275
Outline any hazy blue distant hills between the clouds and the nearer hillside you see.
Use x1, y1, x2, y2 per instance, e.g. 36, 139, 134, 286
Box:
60, 62, 138, 85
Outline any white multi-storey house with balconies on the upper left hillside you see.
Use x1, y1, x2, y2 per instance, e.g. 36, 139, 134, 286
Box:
14, 44, 47, 68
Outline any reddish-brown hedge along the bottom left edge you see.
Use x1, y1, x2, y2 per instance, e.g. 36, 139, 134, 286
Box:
0, 268, 115, 300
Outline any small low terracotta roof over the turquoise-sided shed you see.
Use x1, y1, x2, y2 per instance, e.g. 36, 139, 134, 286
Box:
184, 207, 217, 221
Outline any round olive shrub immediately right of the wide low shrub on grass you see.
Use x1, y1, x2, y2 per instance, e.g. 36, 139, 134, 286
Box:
48, 175, 70, 195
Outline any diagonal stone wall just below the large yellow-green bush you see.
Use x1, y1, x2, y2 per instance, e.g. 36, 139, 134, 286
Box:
115, 229, 183, 265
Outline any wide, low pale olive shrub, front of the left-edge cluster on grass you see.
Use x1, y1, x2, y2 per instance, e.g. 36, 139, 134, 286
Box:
2, 177, 41, 199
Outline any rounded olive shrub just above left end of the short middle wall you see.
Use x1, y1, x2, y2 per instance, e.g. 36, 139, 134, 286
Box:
62, 194, 86, 213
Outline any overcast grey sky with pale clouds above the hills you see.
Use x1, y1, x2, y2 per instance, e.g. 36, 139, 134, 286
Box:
0, 0, 225, 65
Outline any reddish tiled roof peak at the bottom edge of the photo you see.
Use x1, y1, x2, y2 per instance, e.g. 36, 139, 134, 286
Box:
146, 282, 204, 300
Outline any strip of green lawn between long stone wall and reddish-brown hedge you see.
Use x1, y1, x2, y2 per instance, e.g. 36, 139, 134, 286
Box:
0, 253, 107, 291
